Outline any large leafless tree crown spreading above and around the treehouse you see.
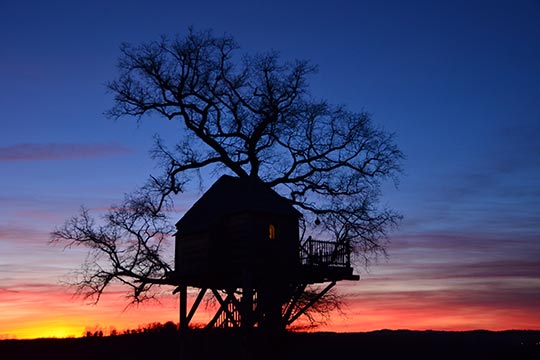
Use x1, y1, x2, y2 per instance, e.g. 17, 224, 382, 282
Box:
52, 29, 403, 326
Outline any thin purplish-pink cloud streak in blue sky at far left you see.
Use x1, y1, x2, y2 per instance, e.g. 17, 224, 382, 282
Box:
0, 143, 132, 161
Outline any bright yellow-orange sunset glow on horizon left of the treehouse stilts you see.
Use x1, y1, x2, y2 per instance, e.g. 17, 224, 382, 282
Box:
0, 286, 178, 340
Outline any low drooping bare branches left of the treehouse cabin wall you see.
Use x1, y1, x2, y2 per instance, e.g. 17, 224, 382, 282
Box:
51, 187, 174, 303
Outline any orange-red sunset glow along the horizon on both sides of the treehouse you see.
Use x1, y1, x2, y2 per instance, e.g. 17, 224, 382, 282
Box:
0, 280, 540, 339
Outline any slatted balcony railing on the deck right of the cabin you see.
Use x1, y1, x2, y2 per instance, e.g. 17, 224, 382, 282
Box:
300, 237, 351, 267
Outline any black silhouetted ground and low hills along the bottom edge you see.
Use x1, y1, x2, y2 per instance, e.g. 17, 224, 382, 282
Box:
0, 330, 540, 360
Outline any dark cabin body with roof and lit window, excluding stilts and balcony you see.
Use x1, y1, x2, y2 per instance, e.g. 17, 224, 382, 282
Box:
175, 176, 300, 288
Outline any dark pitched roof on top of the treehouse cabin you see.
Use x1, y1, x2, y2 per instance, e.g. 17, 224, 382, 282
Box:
176, 175, 300, 234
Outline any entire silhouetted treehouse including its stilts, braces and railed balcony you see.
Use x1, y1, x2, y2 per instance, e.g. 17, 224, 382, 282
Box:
173, 175, 359, 329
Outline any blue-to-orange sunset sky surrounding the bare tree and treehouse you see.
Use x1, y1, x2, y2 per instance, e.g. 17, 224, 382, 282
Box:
0, 0, 540, 339
